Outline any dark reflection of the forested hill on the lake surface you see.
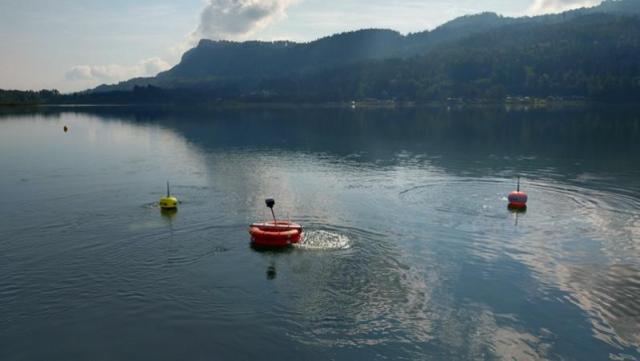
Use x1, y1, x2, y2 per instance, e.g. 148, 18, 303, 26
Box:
6, 107, 640, 186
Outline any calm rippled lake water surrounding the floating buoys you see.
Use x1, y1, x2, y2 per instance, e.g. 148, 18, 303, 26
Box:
0, 108, 640, 361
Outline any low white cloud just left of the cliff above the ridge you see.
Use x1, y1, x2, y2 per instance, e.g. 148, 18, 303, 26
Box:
65, 57, 171, 83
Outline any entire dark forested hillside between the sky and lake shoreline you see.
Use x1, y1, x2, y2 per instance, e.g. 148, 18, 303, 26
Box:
0, 0, 640, 104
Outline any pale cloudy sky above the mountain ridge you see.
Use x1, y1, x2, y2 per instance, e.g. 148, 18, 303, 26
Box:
0, 0, 600, 92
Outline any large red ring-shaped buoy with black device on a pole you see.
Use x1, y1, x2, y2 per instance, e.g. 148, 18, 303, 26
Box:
249, 198, 304, 248
